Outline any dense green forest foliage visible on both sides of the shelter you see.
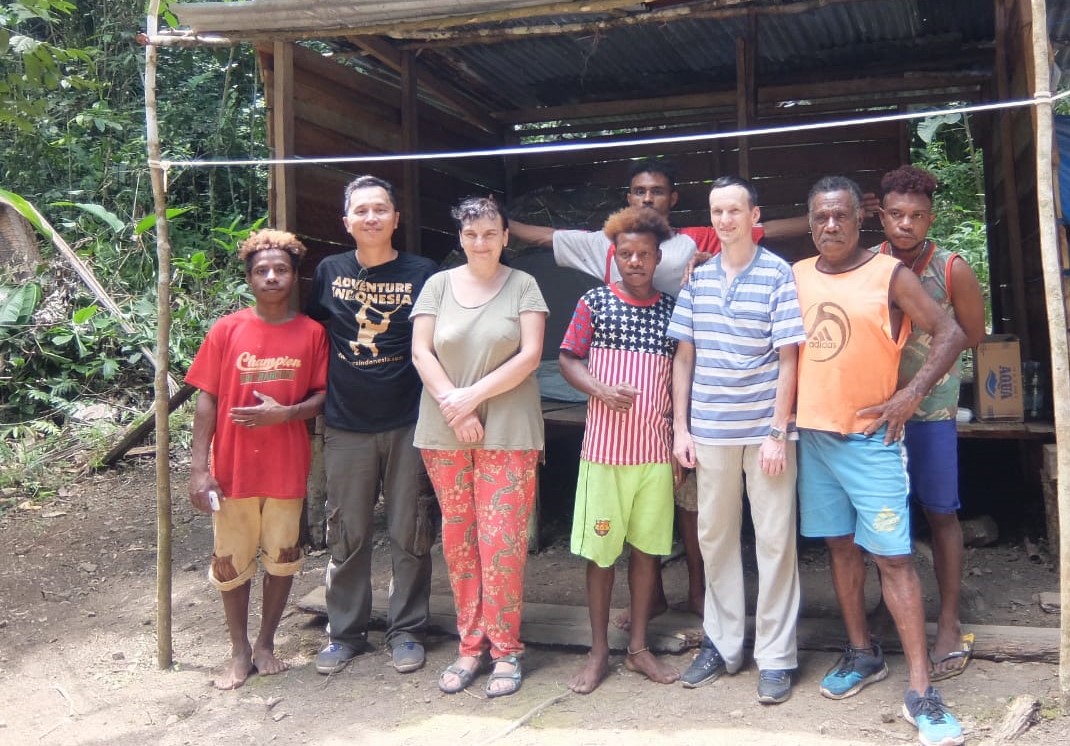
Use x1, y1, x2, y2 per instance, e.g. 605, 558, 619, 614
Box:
0, 0, 989, 507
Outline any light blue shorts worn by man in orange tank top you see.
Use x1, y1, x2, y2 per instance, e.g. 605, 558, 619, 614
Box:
798, 428, 911, 557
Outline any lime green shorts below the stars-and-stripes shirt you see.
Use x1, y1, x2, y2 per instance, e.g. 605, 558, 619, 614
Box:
572, 459, 673, 567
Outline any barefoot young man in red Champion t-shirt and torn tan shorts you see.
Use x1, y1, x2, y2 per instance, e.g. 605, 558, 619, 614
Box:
186, 230, 327, 689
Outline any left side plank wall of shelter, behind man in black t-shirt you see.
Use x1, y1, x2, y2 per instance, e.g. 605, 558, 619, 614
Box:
258, 41, 504, 279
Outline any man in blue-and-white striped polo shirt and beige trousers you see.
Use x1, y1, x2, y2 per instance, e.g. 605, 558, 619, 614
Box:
669, 177, 806, 703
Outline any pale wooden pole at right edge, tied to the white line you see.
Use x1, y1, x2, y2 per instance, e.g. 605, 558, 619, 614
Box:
1031, 0, 1070, 715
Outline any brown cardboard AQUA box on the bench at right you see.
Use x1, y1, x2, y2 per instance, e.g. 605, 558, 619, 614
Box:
974, 334, 1024, 422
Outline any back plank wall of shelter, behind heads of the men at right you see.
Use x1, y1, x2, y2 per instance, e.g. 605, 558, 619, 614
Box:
508, 102, 903, 260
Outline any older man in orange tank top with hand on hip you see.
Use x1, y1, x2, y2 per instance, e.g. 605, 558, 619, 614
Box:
794, 177, 965, 746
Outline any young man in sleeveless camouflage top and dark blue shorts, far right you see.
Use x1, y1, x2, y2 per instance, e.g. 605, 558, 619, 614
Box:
871, 166, 984, 681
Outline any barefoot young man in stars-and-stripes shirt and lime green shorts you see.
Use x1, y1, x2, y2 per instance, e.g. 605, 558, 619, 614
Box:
559, 207, 681, 694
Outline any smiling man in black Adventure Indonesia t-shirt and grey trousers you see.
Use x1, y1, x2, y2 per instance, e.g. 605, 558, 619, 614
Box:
307, 176, 438, 674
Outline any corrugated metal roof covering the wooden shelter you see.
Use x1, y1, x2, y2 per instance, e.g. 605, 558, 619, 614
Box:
172, 0, 1070, 115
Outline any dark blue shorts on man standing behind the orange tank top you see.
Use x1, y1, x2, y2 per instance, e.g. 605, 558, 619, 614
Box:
903, 420, 959, 514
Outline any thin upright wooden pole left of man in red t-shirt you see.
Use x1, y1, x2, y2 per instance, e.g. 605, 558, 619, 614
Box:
144, 0, 173, 668
